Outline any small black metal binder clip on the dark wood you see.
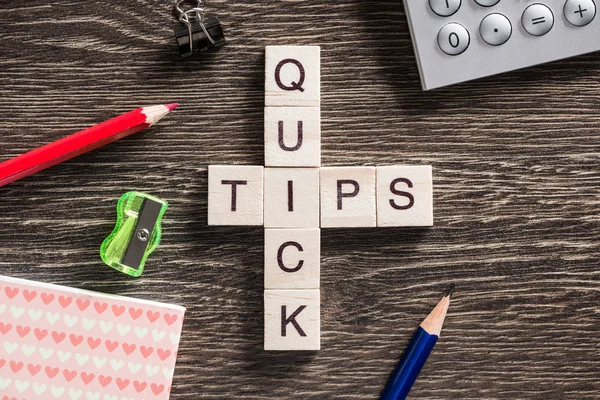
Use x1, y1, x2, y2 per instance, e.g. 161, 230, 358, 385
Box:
175, 0, 225, 58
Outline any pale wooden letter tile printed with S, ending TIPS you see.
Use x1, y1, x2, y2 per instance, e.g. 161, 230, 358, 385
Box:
377, 165, 433, 226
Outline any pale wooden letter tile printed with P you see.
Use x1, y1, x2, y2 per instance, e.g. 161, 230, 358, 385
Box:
321, 167, 377, 228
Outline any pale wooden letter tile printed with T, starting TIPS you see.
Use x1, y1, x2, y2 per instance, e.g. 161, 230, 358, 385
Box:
208, 165, 264, 225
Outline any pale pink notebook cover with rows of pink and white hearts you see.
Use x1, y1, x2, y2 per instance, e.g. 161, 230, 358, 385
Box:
0, 276, 185, 400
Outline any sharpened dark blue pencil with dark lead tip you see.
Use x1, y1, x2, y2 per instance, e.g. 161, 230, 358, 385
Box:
381, 287, 454, 400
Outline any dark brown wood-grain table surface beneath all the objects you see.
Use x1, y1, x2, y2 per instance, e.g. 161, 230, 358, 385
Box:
0, 0, 600, 400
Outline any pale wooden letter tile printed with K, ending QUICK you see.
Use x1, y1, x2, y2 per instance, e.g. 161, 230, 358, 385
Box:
265, 290, 321, 350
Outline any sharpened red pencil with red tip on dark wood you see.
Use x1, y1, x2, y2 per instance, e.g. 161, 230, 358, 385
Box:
0, 103, 177, 187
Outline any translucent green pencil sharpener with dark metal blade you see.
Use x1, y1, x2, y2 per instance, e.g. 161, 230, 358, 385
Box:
100, 192, 168, 276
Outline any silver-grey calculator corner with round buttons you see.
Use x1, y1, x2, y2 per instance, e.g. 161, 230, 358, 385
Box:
404, 0, 600, 90
